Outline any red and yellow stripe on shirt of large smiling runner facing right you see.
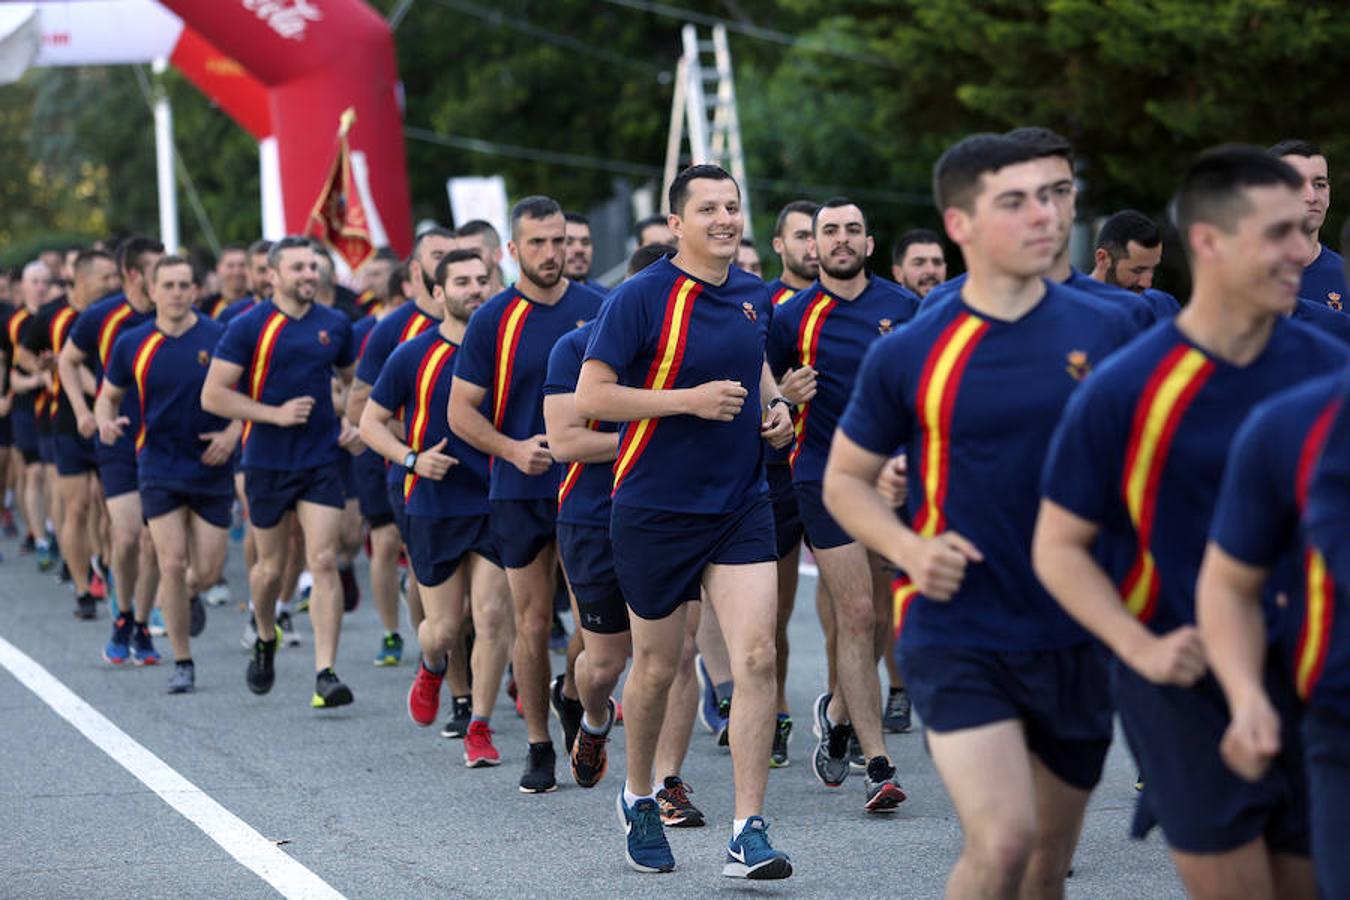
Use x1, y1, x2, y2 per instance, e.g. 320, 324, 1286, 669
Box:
1121, 344, 1214, 622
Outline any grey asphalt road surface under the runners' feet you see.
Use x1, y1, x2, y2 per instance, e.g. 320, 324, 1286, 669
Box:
0, 523, 1183, 900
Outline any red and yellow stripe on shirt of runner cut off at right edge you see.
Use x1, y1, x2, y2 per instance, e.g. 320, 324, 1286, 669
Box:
1293, 398, 1341, 700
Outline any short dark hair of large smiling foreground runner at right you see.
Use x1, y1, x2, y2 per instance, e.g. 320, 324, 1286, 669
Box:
1172, 144, 1303, 255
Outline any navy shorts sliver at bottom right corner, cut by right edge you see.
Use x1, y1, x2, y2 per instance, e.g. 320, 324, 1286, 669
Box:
1303, 708, 1350, 897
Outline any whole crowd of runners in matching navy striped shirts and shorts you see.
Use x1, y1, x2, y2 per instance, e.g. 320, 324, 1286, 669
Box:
0, 127, 1350, 900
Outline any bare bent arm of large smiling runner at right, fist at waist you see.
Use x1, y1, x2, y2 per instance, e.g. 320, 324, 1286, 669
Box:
1031, 499, 1204, 687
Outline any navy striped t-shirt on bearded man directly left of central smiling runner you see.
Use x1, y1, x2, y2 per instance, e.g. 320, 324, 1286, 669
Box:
455, 279, 604, 501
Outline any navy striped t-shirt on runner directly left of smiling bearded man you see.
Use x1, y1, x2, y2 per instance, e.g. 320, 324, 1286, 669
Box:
104, 314, 234, 494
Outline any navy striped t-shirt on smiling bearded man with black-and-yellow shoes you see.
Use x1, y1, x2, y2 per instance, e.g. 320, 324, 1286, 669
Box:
215, 300, 356, 471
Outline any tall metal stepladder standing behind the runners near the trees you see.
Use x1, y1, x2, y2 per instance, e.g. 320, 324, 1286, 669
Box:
662, 24, 752, 237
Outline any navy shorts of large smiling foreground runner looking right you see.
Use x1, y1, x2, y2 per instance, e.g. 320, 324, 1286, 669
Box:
1114, 663, 1308, 855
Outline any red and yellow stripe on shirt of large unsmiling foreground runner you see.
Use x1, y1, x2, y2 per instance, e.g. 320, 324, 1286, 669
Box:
914, 313, 990, 537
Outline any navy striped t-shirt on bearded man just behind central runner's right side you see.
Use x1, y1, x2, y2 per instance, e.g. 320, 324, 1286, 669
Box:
768, 277, 919, 482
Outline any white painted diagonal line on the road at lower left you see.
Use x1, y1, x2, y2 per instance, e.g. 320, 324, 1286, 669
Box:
0, 637, 343, 900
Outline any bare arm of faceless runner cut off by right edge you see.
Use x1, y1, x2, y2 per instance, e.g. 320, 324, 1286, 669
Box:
1196, 541, 1280, 781
